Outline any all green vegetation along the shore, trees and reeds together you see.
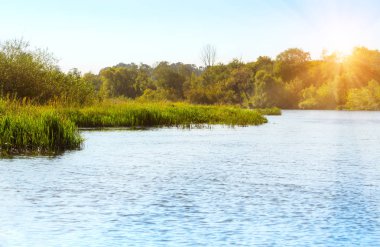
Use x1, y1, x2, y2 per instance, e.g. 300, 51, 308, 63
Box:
4, 37, 380, 154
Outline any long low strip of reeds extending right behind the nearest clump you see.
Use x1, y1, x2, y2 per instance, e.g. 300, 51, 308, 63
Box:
58, 101, 267, 128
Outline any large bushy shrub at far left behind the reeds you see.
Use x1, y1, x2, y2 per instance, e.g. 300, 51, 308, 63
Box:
0, 40, 95, 104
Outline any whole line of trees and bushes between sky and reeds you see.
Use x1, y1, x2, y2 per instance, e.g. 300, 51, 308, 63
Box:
0, 41, 380, 110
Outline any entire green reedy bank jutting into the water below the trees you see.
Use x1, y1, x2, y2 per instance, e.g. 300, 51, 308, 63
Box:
0, 100, 274, 155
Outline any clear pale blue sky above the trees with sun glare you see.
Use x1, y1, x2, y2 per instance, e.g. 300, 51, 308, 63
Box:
0, 0, 380, 73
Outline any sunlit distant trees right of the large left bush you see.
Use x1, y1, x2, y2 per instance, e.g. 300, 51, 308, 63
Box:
83, 47, 380, 110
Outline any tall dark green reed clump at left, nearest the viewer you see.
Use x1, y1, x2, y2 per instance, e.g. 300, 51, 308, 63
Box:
0, 111, 83, 155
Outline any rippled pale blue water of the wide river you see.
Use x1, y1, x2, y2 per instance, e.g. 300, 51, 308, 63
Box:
0, 111, 380, 246
